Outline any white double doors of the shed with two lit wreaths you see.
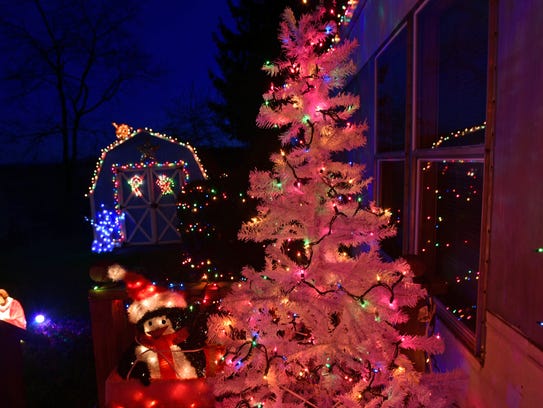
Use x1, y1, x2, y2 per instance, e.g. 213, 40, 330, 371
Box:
116, 166, 186, 245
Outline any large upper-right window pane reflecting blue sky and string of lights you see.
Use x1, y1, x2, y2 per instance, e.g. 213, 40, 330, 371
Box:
416, 0, 488, 148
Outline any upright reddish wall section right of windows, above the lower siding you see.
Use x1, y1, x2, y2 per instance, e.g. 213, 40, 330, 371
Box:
488, 0, 543, 348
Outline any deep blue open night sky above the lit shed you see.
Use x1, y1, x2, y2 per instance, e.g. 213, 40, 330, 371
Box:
0, 0, 231, 164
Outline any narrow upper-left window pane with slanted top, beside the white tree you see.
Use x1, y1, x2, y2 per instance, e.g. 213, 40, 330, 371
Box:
376, 28, 407, 152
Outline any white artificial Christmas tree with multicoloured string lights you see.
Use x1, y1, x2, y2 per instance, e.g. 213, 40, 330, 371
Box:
209, 9, 445, 407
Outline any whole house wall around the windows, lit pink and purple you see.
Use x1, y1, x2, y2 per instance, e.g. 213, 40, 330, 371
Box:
347, 0, 543, 408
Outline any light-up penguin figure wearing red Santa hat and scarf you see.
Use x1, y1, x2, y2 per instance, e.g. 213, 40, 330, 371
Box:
108, 265, 206, 385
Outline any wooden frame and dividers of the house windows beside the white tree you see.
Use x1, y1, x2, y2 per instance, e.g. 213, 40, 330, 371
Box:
372, 0, 497, 356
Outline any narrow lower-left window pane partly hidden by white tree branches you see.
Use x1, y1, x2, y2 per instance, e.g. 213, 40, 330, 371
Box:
379, 160, 404, 259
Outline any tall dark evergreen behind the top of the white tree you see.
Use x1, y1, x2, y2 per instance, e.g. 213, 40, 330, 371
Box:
209, 0, 346, 170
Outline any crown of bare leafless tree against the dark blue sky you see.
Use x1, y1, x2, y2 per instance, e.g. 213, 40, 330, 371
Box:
0, 0, 160, 174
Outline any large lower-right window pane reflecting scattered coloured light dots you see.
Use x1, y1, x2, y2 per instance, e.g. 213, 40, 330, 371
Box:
419, 161, 483, 331
